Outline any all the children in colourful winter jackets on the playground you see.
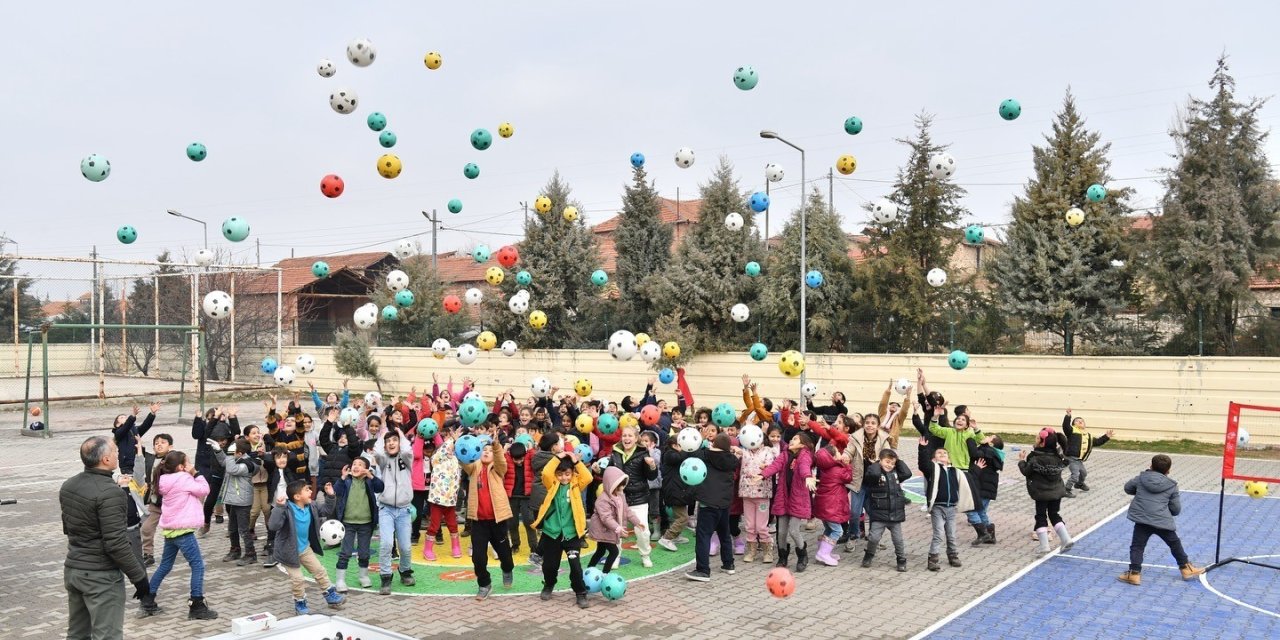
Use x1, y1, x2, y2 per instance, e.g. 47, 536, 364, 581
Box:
102, 370, 1199, 620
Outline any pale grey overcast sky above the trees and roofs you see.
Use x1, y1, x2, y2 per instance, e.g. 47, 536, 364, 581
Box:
0, 0, 1280, 294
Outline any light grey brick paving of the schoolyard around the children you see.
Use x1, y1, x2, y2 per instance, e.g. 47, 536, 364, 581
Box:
0, 402, 1249, 640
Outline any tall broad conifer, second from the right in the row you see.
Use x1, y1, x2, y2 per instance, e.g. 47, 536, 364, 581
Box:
991, 91, 1132, 356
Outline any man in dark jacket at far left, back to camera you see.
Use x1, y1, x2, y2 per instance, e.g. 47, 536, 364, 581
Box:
58, 435, 151, 640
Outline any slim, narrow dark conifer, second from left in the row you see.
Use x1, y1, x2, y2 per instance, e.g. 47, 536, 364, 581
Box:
613, 166, 673, 329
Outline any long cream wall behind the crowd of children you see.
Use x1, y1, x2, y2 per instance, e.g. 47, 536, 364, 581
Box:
230, 347, 1280, 445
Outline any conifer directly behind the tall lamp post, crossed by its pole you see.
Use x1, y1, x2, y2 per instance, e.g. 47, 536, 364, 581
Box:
751, 189, 854, 352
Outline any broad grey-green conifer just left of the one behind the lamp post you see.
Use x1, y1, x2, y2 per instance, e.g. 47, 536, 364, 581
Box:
644, 157, 764, 351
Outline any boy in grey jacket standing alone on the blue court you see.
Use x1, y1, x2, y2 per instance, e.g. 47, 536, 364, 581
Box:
1116, 453, 1204, 586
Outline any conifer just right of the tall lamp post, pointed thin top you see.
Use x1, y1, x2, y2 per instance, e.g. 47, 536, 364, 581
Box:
856, 114, 969, 353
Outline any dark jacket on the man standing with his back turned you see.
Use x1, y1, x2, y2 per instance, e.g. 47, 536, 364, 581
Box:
58, 468, 147, 582
